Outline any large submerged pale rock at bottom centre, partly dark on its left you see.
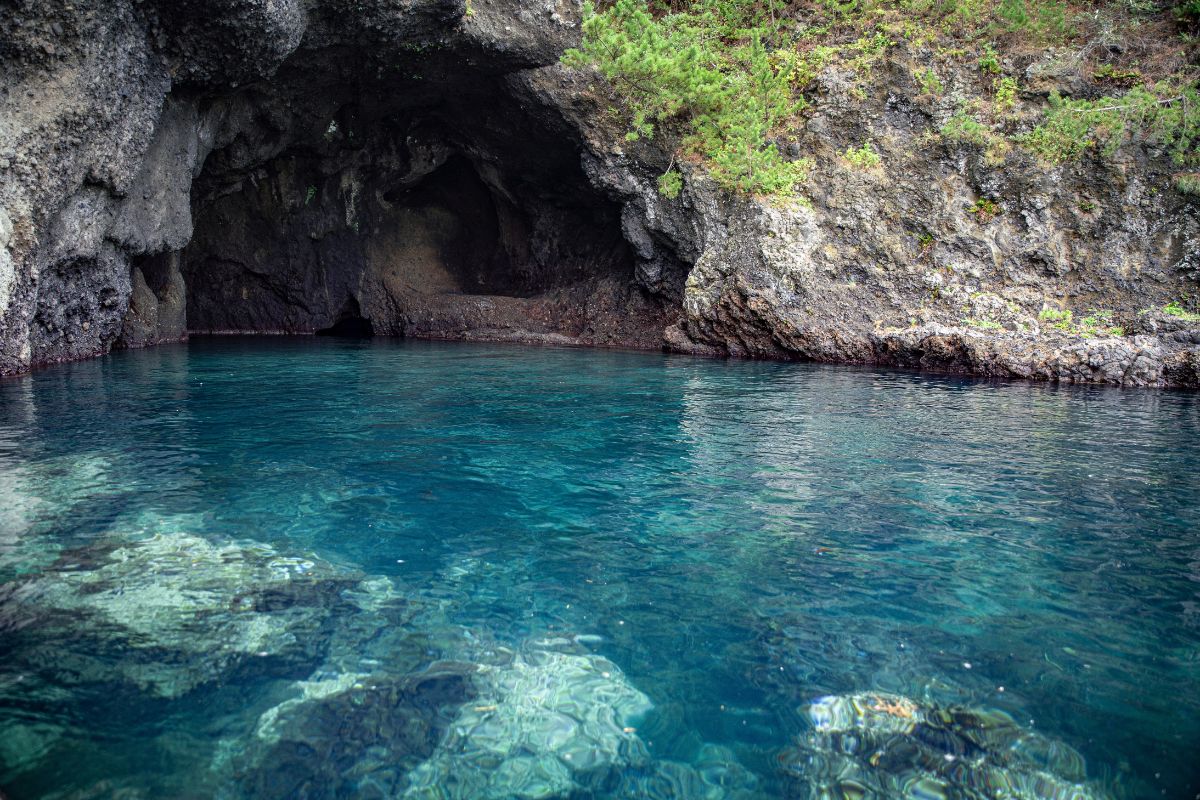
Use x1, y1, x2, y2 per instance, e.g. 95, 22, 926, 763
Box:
228, 639, 762, 800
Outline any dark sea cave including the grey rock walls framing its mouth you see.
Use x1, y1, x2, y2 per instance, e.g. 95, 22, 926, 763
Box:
0, 0, 705, 374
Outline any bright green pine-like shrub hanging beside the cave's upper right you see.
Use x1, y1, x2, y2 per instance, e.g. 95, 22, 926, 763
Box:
563, 0, 808, 194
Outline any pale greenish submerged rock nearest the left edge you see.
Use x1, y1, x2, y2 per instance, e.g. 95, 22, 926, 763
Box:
12, 516, 369, 698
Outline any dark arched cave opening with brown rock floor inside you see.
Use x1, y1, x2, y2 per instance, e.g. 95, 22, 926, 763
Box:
170, 30, 684, 348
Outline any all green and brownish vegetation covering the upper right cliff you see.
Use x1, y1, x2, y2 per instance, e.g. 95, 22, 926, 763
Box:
564, 0, 1200, 196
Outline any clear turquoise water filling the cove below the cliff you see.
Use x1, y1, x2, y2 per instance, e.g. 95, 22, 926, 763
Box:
0, 338, 1200, 800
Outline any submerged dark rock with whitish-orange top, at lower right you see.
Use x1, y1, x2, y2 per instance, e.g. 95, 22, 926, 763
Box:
784, 692, 1108, 800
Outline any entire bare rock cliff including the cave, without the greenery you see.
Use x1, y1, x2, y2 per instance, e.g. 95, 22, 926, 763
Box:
0, 0, 1200, 386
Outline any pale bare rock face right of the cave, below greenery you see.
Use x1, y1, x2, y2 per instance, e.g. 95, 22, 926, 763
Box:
546, 48, 1200, 386
